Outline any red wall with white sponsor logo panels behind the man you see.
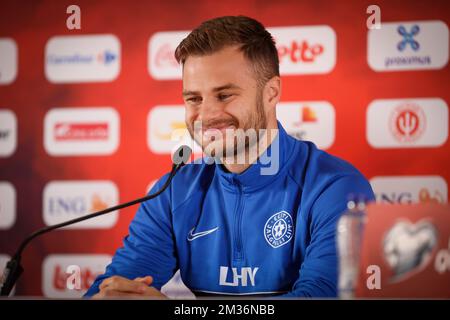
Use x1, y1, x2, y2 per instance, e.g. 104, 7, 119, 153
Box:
0, 0, 450, 298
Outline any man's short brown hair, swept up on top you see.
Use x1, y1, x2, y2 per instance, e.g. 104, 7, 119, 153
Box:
175, 16, 280, 84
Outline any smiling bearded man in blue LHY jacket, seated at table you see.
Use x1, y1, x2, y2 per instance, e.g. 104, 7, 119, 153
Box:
86, 16, 373, 298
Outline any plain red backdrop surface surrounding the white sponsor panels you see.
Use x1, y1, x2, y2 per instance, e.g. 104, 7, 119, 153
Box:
0, 0, 450, 295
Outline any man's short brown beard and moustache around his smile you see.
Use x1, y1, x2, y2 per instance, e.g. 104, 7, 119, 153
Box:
187, 90, 267, 160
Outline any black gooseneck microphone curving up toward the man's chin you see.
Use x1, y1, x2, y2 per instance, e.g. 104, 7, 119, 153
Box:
0, 145, 192, 296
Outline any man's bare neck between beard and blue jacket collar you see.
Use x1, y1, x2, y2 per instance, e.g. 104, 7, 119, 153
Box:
222, 123, 278, 174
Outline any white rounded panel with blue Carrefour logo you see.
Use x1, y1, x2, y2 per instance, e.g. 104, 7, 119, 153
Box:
45, 35, 120, 83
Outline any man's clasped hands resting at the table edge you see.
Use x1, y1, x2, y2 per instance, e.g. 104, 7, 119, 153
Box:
92, 276, 167, 299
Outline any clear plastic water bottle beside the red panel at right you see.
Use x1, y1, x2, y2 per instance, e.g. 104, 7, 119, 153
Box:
337, 197, 366, 299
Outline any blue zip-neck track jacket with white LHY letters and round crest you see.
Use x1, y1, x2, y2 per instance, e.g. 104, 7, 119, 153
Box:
85, 123, 374, 297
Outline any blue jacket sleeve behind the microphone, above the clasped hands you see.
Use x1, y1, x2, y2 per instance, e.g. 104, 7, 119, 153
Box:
84, 174, 177, 297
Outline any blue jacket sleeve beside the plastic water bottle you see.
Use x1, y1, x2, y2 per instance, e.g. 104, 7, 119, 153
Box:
281, 174, 374, 297
